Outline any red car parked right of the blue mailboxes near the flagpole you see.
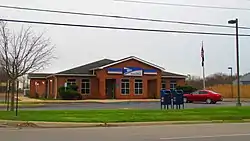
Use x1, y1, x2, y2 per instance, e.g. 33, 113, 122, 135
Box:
184, 90, 222, 104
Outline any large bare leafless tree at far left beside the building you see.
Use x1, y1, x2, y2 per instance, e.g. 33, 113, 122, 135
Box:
0, 21, 54, 111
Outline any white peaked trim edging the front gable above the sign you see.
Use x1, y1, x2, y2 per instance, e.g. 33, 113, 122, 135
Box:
95, 56, 165, 71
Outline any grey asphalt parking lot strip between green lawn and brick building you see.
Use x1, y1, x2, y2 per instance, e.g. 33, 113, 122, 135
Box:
0, 102, 250, 110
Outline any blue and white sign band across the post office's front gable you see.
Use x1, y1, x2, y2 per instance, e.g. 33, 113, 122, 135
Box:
108, 67, 157, 76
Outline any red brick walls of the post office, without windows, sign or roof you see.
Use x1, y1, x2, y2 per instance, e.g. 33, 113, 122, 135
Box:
30, 60, 185, 99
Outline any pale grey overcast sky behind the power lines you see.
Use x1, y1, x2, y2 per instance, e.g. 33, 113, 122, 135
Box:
0, 0, 250, 76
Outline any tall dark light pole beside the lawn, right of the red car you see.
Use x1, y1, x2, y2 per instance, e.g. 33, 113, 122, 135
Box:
228, 19, 241, 106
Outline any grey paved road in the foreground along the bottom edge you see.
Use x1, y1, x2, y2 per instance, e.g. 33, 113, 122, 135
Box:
0, 123, 250, 141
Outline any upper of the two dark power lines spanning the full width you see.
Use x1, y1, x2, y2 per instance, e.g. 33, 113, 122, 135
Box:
0, 5, 250, 29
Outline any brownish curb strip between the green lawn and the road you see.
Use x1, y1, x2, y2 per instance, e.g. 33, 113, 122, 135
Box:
0, 119, 250, 128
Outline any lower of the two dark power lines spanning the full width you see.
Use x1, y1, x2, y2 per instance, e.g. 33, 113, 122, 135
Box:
0, 19, 250, 37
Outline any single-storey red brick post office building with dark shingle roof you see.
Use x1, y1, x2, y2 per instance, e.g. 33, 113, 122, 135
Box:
28, 56, 186, 99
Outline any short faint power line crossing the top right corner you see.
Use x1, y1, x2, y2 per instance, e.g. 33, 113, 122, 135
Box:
114, 0, 250, 11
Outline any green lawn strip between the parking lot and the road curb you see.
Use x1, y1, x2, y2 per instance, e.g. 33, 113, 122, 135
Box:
0, 107, 250, 122
